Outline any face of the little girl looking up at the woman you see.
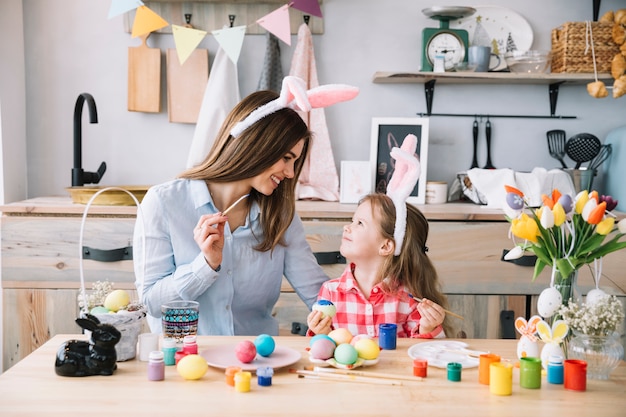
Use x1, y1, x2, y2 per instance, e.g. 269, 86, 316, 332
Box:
339, 201, 389, 261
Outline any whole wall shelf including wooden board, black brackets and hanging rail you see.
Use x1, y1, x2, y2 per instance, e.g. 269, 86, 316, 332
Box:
373, 71, 613, 119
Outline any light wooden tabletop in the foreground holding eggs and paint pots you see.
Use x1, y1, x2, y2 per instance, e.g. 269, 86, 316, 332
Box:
0, 335, 626, 417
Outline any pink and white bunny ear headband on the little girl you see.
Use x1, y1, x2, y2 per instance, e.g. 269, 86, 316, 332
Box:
387, 134, 421, 256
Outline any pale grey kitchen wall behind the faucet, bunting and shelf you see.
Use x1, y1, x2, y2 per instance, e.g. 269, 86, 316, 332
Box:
0, 0, 626, 202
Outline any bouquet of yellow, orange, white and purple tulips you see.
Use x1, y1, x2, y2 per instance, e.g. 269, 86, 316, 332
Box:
504, 186, 626, 280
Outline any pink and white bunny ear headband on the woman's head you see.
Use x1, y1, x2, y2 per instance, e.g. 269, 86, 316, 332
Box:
230, 76, 359, 137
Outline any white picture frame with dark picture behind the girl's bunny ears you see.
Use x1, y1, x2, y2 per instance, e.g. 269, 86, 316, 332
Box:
370, 117, 429, 204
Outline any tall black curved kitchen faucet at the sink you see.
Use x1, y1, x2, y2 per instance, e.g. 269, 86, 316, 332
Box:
72, 93, 107, 187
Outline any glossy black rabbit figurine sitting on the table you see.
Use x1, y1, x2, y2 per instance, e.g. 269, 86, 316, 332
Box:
54, 314, 122, 376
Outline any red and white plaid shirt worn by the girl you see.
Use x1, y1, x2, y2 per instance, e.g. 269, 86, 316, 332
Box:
318, 264, 445, 339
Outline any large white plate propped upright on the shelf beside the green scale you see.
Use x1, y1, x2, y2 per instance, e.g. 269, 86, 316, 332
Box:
450, 6, 533, 71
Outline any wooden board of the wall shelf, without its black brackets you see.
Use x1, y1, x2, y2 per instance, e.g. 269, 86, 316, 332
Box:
373, 71, 613, 85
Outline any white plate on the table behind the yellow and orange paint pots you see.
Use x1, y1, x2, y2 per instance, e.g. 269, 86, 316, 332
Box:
408, 340, 479, 368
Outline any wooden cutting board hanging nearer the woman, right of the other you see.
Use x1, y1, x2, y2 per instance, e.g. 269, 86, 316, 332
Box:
166, 49, 209, 123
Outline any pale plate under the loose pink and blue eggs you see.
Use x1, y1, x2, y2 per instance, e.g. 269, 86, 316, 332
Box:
200, 345, 302, 372
